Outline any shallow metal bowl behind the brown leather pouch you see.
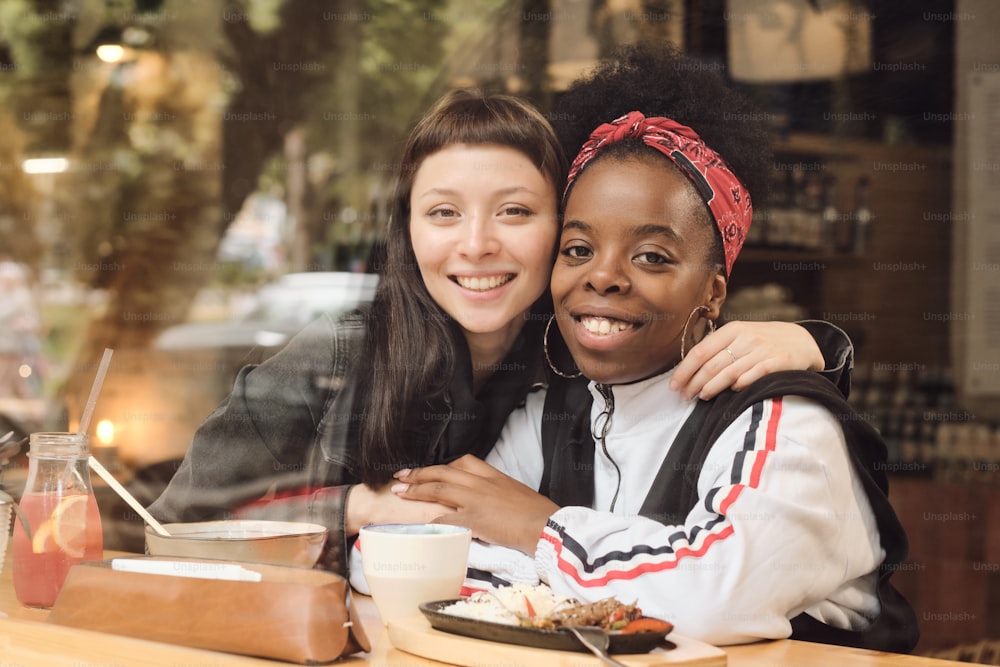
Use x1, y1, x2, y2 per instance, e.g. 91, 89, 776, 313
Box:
146, 520, 328, 567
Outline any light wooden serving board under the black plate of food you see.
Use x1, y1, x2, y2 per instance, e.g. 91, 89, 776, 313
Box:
387, 618, 726, 667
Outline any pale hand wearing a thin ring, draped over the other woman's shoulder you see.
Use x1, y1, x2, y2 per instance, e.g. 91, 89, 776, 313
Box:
670, 321, 824, 400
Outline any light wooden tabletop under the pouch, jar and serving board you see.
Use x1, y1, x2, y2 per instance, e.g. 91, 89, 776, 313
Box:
0, 550, 967, 667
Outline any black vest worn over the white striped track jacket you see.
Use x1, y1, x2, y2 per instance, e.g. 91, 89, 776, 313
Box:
539, 371, 920, 653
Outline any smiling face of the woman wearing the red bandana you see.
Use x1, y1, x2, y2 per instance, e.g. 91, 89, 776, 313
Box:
552, 156, 726, 384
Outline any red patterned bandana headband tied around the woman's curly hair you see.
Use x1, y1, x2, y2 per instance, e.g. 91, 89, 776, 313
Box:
563, 111, 753, 276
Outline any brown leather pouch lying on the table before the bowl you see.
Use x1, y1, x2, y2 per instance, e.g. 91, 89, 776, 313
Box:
49, 557, 371, 664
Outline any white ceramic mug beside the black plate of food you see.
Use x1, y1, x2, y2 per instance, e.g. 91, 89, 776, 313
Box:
359, 523, 472, 624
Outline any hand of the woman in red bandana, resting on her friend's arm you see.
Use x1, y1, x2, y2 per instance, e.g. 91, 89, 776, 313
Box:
392, 454, 559, 556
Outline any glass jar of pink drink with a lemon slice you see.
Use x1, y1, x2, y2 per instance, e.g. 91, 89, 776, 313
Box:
12, 433, 104, 609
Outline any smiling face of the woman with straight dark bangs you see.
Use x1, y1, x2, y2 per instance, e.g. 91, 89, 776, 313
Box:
410, 144, 559, 344
